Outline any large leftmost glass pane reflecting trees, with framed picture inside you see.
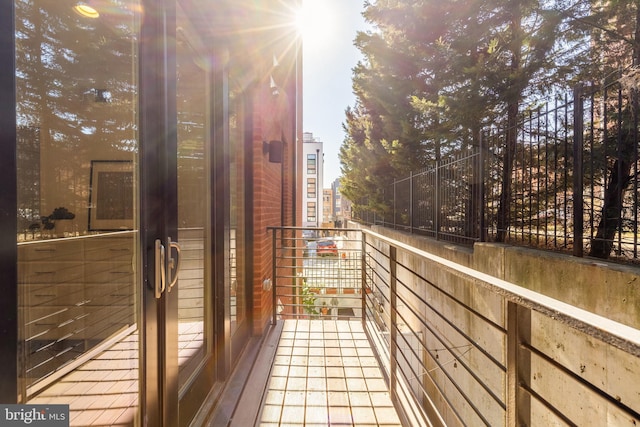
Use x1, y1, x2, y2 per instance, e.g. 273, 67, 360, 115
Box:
14, 0, 140, 425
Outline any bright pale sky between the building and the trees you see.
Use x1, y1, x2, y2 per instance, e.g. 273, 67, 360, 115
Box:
299, 0, 366, 188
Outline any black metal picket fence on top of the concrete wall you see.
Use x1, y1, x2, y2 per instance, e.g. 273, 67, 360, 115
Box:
353, 81, 640, 260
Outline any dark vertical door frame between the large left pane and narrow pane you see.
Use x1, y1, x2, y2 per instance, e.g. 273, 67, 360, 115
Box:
138, 0, 178, 426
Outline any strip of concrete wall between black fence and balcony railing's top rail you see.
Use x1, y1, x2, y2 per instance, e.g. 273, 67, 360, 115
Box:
372, 226, 640, 329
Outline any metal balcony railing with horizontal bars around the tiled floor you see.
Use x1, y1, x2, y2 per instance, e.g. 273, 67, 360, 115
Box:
272, 228, 640, 426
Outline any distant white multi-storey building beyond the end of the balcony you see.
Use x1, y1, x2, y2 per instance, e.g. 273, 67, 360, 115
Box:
301, 132, 324, 227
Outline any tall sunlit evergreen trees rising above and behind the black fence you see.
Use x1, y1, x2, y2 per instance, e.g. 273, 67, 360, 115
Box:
340, 0, 640, 256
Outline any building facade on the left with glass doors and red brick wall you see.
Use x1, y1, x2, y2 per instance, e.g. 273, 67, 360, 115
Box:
0, 0, 300, 426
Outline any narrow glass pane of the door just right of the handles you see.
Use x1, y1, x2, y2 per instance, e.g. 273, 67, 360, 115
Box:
175, 9, 214, 425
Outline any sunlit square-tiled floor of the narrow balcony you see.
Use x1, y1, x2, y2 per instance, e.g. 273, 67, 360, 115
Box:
258, 320, 401, 427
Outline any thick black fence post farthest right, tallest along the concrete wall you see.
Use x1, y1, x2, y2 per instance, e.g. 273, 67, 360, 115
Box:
573, 83, 584, 257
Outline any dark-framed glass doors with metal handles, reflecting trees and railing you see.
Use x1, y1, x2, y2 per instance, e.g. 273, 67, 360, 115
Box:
8, 0, 244, 426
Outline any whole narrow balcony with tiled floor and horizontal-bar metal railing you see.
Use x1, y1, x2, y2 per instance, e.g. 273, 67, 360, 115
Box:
216, 228, 640, 426
